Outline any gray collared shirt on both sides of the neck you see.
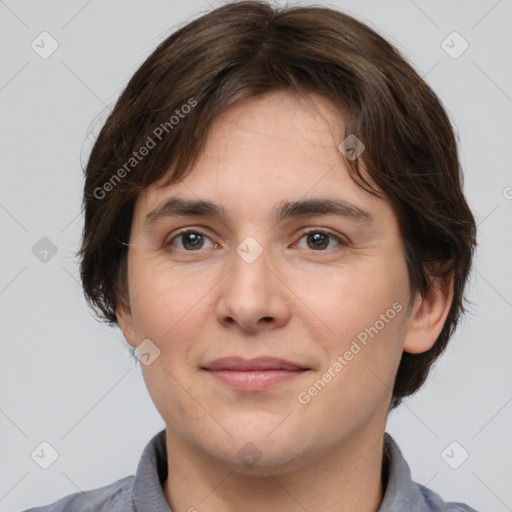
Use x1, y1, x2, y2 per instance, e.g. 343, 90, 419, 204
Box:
25, 429, 477, 512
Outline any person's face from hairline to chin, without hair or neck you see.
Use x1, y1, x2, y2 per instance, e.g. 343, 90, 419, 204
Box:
118, 92, 420, 471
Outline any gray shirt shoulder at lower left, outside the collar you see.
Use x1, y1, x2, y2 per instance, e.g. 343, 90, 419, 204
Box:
24, 476, 134, 512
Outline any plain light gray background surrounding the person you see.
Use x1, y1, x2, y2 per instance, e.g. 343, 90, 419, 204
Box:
0, 0, 512, 512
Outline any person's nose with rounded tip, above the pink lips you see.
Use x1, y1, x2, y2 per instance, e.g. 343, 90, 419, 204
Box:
217, 240, 291, 332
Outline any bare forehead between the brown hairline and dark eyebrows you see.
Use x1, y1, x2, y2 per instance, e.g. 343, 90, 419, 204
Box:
136, 91, 384, 220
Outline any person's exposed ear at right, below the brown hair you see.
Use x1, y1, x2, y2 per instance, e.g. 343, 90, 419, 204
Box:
403, 274, 453, 354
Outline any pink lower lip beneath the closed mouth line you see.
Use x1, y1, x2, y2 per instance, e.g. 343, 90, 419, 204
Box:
208, 370, 304, 391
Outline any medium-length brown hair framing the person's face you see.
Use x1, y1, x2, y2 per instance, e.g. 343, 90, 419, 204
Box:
78, 1, 476, 408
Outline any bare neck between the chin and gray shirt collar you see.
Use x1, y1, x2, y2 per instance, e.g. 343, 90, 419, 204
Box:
163, 428, 386, 512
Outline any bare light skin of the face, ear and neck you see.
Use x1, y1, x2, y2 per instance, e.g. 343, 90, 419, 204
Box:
117, 92, 452, 512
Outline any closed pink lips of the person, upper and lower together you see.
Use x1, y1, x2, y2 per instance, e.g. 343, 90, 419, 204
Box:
201, 357, 310, 391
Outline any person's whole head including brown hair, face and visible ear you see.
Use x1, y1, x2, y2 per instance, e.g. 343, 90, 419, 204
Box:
79, 1, 476, 472
